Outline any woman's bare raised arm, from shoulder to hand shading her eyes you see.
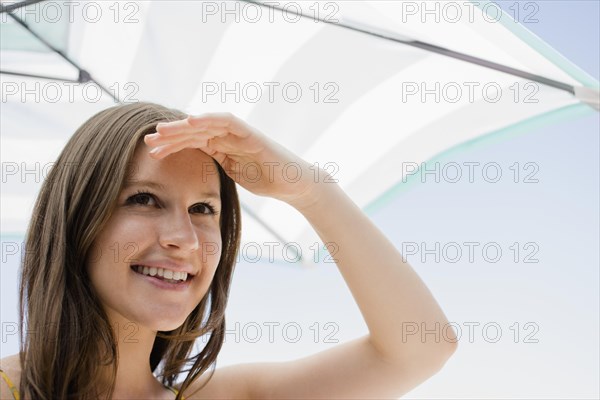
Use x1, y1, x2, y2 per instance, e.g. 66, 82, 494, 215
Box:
146, 113, 457, 398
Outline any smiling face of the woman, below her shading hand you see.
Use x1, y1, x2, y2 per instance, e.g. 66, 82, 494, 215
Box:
88, 142, 221, 331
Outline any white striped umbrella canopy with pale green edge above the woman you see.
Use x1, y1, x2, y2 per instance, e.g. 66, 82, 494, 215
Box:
0, 1, 598, 261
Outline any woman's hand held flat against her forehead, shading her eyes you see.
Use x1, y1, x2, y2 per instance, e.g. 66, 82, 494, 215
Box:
144, 113, 326, 209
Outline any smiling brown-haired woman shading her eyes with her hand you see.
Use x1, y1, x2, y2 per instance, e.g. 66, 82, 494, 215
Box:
0, 103, 457, 400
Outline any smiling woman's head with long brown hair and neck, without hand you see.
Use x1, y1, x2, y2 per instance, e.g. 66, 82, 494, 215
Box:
2, 104, 240, 399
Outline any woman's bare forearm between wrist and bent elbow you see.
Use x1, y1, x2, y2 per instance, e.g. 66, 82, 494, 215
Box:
297, 182, 457, 365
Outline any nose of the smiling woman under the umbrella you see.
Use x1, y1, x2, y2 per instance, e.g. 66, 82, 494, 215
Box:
159, 210, 200, 251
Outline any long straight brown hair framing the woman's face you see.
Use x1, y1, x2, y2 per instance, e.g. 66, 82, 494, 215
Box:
19, 103, 241, 400
